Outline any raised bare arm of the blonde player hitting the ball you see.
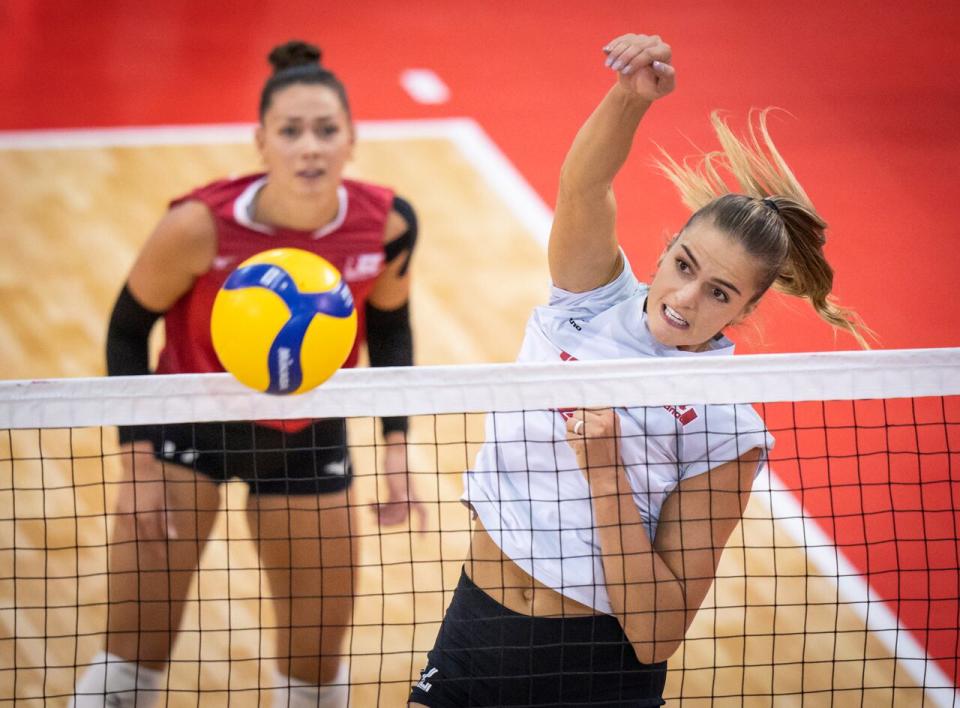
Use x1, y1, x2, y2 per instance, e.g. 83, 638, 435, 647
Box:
548, 34, 675, 292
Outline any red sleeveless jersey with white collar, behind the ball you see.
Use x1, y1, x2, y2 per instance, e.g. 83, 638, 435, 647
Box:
157, 174, 393, 390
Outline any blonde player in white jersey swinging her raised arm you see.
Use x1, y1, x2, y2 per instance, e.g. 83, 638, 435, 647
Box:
410, 34, 865, 706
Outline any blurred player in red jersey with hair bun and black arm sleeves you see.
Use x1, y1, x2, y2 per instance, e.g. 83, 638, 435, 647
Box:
74, 42, 424, 706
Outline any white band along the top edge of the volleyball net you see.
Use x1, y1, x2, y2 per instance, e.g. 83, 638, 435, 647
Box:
0, 348, 960, 429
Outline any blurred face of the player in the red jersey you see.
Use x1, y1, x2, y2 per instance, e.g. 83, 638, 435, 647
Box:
257, 84, 354, 195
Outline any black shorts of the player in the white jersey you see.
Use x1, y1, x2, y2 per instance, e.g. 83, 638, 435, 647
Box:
410, 572, 667, 708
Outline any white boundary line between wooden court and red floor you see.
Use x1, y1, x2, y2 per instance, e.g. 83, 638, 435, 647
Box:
0, 118, 960, 706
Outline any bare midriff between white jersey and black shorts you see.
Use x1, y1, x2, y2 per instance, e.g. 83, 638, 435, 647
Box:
464, 519, 600, 617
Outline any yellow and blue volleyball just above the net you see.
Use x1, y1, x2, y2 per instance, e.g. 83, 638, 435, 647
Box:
210, 248, 357, 394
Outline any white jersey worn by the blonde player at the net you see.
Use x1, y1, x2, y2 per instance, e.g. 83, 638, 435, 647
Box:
463, 263, 773, 614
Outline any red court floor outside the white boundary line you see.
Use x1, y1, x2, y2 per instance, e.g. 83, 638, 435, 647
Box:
0, 0, 960, 692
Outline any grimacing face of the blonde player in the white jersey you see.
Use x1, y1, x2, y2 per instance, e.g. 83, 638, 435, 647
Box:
647, 221, 760, 351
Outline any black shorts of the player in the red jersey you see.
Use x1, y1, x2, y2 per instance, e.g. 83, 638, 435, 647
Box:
146, 418, 353, 494
